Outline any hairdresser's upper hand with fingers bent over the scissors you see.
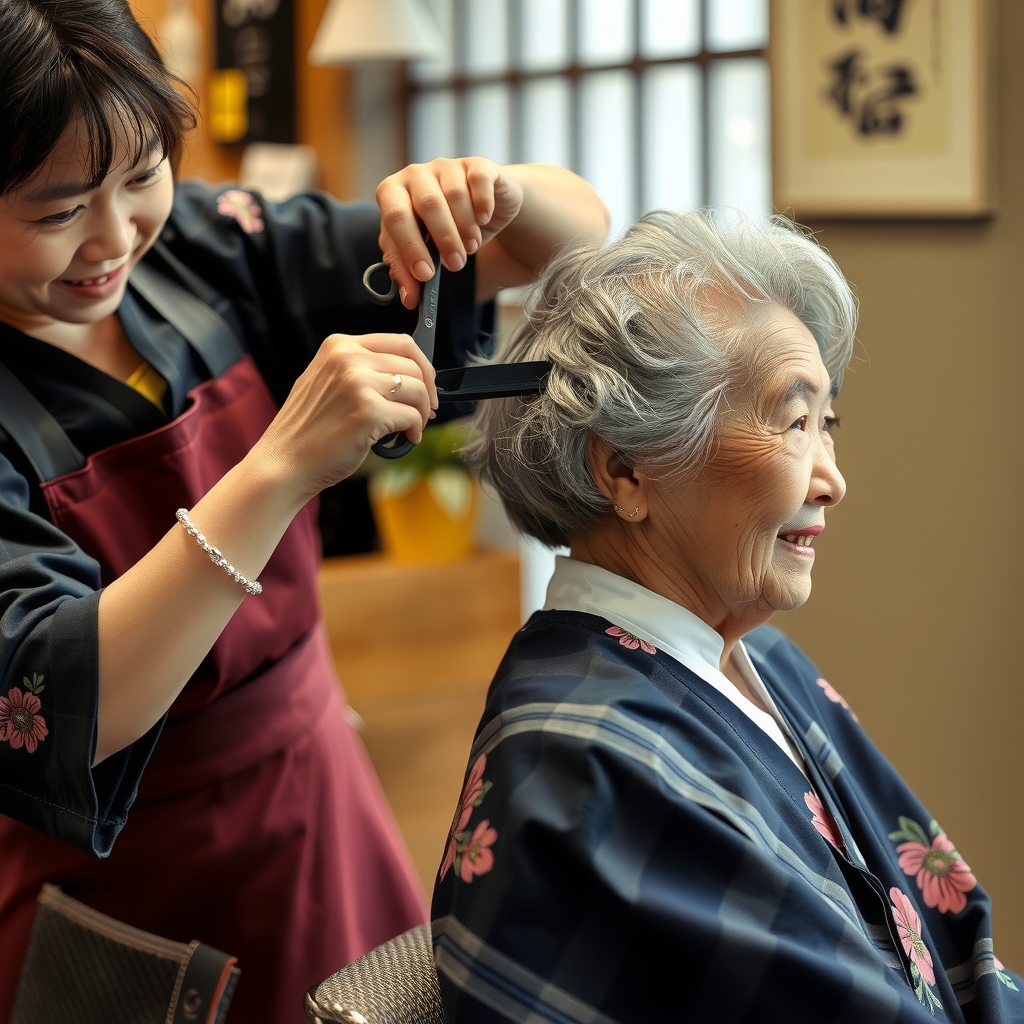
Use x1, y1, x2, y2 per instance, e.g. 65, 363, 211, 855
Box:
377, 157, 523, 309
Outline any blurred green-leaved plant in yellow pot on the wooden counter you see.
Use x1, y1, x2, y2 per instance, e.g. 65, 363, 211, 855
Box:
367, 420, 479, 564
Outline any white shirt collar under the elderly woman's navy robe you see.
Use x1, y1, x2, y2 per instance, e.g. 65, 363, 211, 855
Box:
544, 555, 806, 774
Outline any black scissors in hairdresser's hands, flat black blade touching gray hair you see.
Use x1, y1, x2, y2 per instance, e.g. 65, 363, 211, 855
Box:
362, 238, 551, 459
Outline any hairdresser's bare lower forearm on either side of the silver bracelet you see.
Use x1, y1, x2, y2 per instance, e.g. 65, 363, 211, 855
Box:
95, 450, 302, 762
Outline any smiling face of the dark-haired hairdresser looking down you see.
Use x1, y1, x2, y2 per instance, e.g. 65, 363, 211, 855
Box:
0, 122, 174, 333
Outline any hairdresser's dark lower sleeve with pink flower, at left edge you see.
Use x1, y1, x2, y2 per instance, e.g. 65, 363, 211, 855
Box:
0, 455, 160, 857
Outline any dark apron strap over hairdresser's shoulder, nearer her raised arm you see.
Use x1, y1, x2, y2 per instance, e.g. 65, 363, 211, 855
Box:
129, 249, 245, 377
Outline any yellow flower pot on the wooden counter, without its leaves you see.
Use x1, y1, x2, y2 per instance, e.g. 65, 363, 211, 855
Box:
370, 466, 479, 565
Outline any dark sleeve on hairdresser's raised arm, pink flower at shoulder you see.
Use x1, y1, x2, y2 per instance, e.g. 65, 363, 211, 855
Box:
164, 181, 493, 399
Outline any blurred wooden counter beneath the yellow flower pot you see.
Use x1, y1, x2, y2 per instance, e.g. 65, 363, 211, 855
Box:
321, 550, 520, 896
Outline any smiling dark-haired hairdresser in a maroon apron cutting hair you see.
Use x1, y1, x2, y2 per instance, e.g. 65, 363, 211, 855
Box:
0, 0, 606, 1022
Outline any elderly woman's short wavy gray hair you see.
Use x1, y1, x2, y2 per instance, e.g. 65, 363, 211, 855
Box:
465, 202, 857, 547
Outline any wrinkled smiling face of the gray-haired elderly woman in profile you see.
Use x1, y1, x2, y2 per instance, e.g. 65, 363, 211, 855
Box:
650, 307, 846, 623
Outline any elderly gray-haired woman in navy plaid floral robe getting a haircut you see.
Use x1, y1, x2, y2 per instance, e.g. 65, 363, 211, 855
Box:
432, 212, 1024, 1024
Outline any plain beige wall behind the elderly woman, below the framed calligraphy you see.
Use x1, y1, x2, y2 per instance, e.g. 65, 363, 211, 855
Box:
774, 0, 1024, 971
